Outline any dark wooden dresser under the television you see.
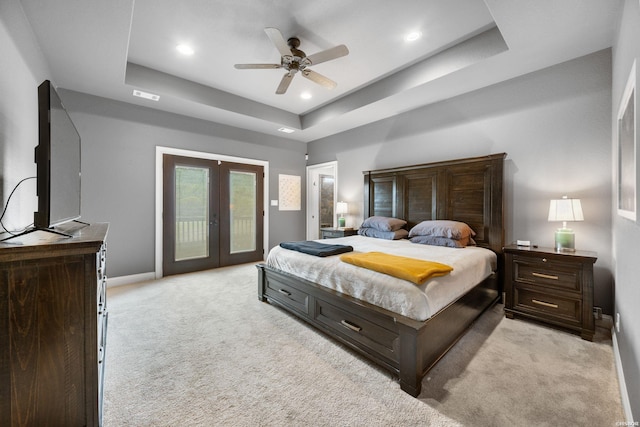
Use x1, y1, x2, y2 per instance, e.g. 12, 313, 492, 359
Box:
0, 222, 108, 426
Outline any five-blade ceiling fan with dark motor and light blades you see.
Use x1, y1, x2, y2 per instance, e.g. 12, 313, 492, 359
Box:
234, 28, 349, 95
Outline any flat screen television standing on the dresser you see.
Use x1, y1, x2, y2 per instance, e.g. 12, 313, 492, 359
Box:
33, 80, 81, 230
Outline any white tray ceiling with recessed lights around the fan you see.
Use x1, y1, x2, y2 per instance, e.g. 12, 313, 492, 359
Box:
21, 0, 621, 142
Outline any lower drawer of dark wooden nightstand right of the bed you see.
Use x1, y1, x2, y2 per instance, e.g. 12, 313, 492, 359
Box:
514, 286, 582, 324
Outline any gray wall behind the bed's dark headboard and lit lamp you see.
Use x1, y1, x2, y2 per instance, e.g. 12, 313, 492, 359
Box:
308, 50, 613, 313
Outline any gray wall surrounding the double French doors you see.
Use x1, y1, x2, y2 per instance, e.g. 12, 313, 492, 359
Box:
59, 90, 306, 277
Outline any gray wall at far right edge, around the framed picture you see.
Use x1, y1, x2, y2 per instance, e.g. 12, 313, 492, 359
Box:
610, 0, 640, 421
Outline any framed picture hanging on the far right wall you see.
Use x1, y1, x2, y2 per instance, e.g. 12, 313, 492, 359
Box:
616, 61, 638, 221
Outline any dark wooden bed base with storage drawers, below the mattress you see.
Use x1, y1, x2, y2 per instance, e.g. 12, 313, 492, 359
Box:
257, 264, 499, 396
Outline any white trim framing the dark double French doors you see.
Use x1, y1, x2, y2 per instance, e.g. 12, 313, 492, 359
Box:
155, 146, 269, 279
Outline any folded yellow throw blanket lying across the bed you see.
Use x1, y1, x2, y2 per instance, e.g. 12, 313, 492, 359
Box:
340, 252, 453, 285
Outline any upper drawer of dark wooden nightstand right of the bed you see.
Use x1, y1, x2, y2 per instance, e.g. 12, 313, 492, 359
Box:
513, 255, 582, 292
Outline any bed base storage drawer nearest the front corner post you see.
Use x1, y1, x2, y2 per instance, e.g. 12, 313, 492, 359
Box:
315, 299, 400, 366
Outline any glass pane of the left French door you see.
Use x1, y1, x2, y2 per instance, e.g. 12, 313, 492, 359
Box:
175, 166, 209, 261
